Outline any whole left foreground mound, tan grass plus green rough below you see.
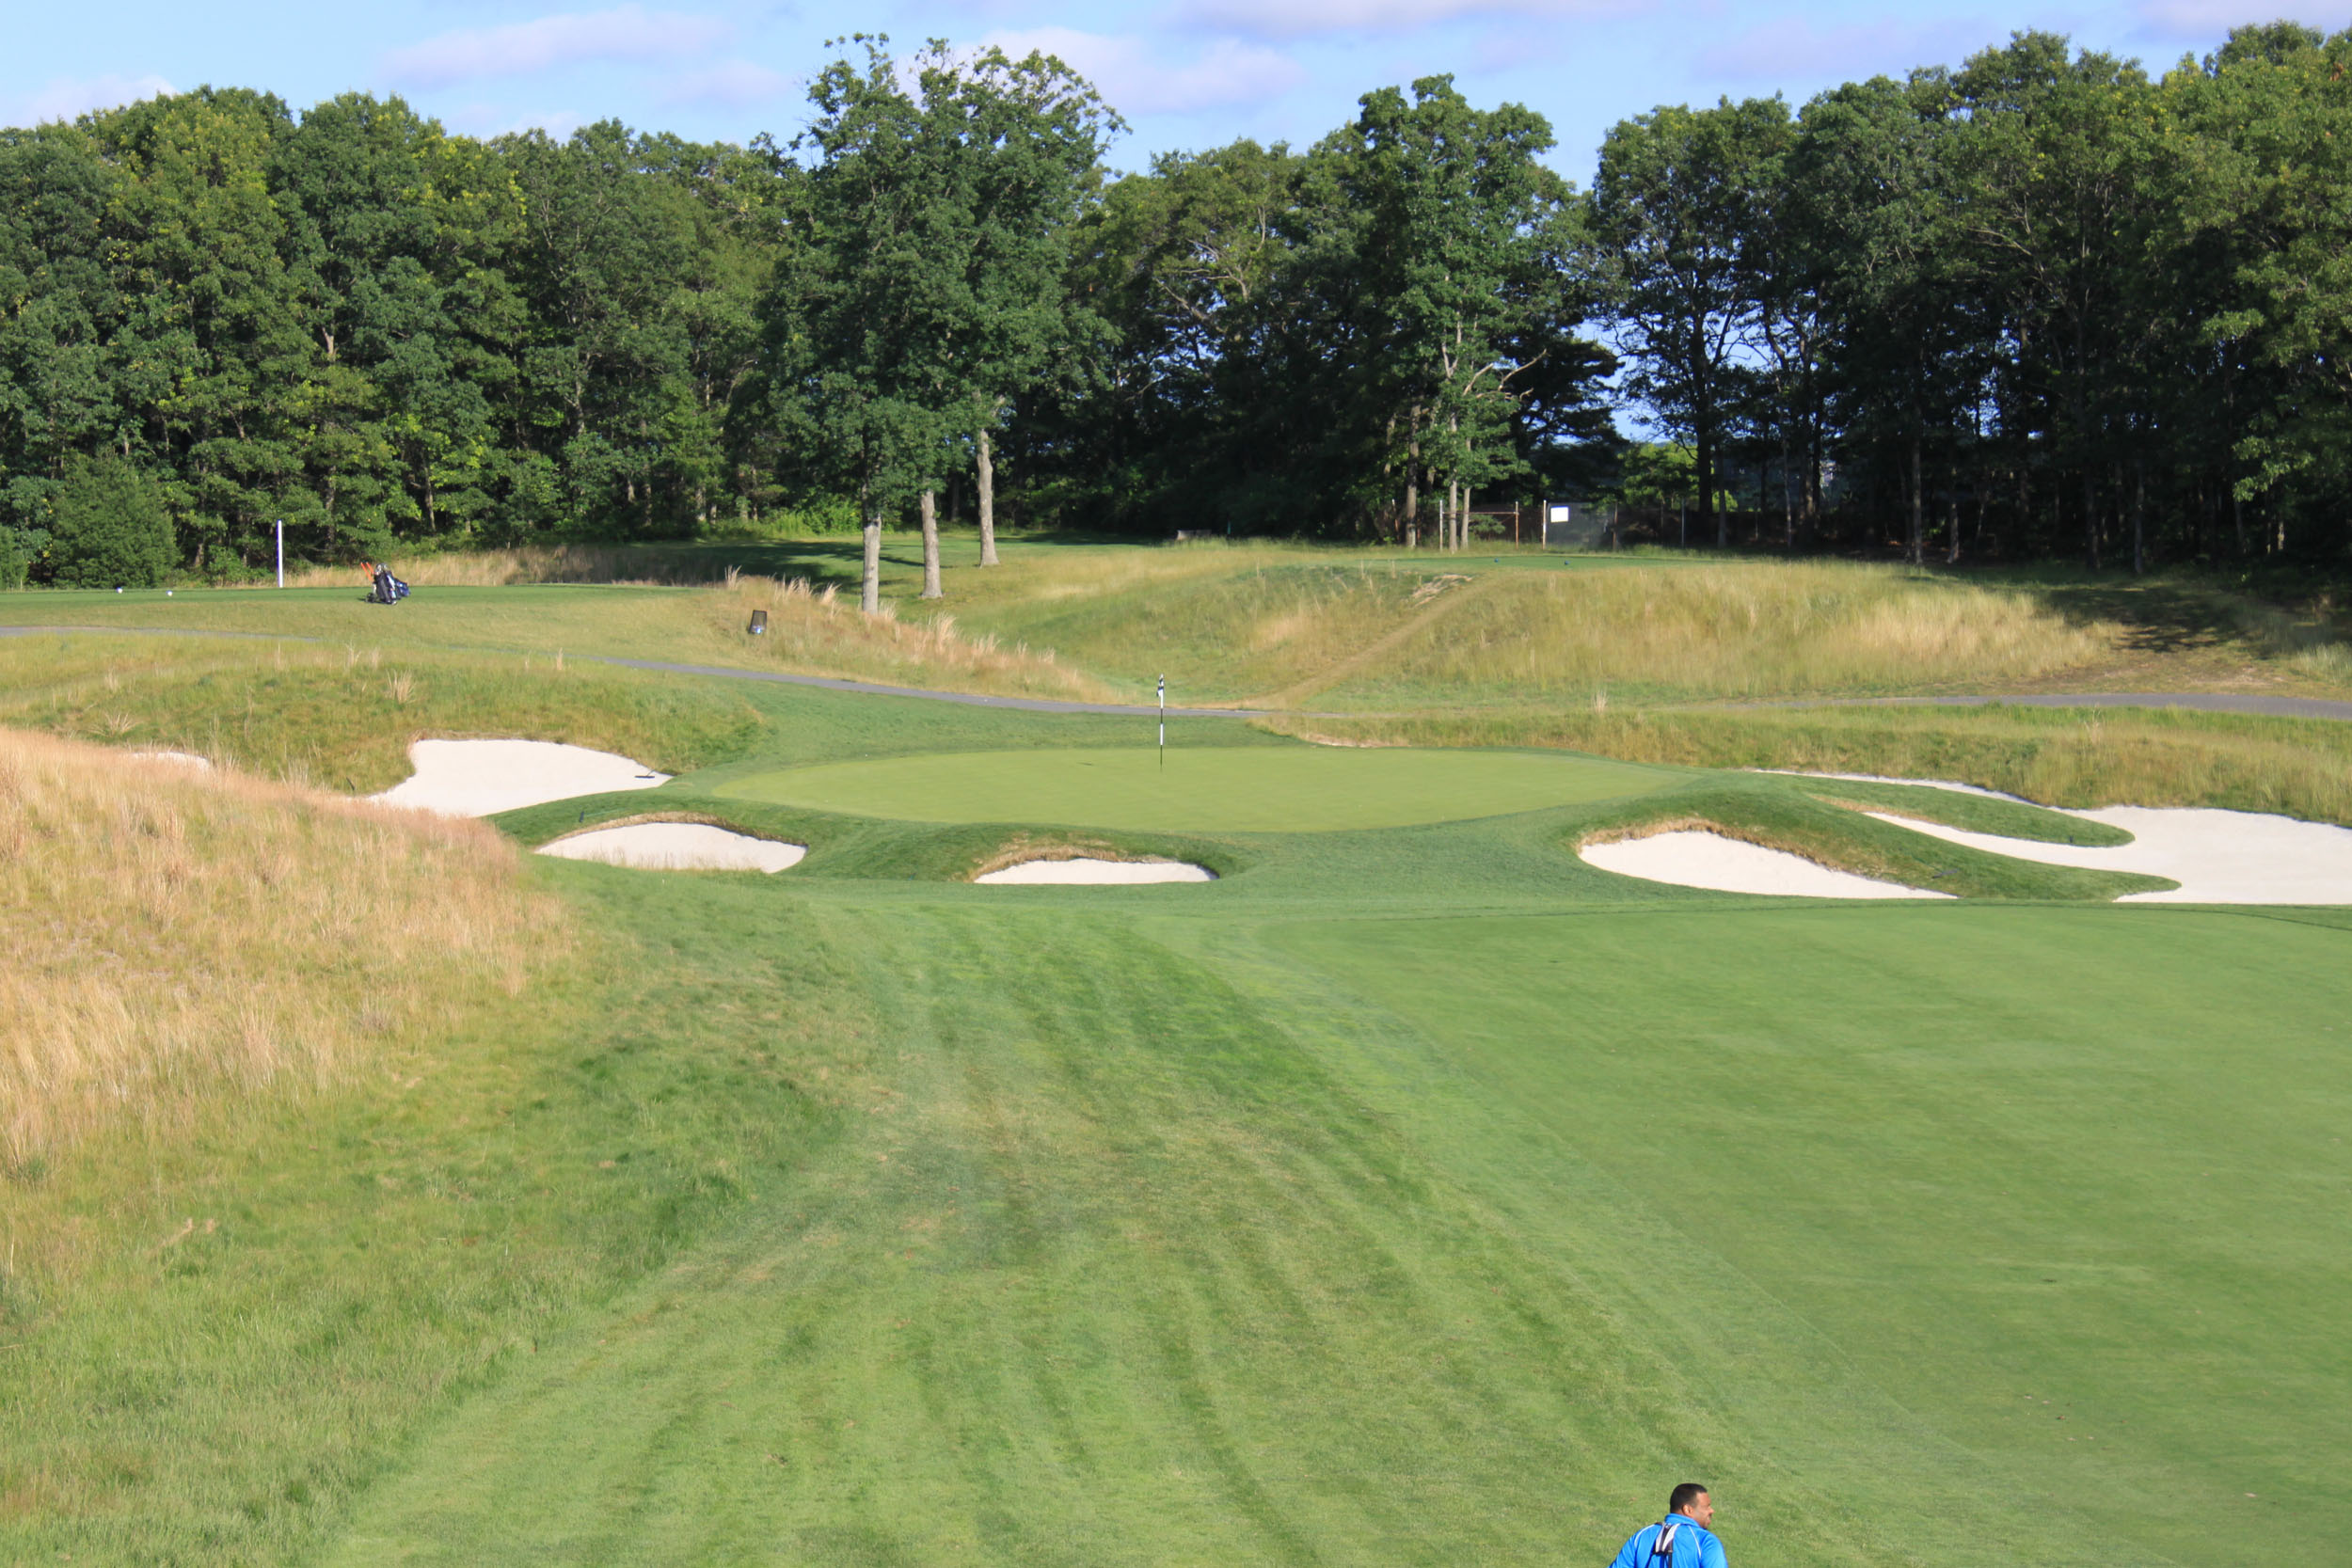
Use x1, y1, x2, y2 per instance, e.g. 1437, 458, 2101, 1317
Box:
0, 731, 868, 1563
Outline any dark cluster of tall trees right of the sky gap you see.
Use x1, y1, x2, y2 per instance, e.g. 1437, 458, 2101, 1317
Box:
1593, 24, 2352, 566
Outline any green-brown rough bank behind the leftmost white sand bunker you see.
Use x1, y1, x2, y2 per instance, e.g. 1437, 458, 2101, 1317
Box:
0, 635, 762, 792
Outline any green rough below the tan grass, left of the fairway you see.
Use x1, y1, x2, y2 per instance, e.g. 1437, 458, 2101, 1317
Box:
0, 864, 847, 1568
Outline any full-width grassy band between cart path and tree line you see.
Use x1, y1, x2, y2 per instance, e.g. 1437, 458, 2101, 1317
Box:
18, 538, 2352, 712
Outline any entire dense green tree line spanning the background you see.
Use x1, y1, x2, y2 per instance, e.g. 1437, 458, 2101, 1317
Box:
13, 24, 2352, 593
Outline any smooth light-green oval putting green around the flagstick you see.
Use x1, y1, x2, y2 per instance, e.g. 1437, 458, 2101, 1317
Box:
718, 745, 1677, 832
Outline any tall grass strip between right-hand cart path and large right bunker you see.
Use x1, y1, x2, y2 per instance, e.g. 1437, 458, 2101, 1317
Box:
1273, 705, 2352, 828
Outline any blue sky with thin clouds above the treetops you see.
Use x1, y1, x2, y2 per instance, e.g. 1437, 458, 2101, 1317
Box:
0, 0, 2352, 183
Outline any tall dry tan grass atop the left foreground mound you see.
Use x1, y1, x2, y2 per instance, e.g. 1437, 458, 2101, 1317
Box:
0, 729, 567, 1168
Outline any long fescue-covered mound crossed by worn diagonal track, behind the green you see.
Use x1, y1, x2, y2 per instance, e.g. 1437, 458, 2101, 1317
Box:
946, 550, 2122, 707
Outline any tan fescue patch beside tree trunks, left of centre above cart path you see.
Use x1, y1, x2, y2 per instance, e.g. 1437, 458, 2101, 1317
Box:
696, 571, 1115, 701
